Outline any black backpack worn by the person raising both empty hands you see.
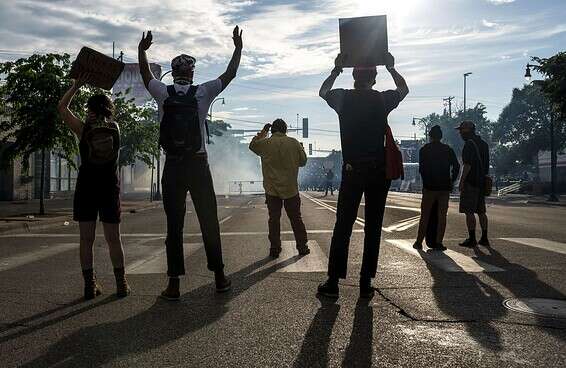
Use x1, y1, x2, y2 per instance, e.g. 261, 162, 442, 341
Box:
159, 85, 202, 155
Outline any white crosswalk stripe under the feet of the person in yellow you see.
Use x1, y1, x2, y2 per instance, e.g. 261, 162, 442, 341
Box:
254, 240, 328, 273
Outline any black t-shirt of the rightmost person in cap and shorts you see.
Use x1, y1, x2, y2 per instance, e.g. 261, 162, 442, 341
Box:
462, 135, 489, 187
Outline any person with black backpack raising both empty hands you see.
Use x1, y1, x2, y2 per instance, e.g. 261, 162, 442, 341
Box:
138, 26, 242, 300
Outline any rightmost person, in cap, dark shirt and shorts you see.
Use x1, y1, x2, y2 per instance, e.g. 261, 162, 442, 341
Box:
456, 121, 489, 248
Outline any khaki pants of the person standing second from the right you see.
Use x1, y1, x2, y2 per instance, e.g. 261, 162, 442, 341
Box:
417, 189, 450, 244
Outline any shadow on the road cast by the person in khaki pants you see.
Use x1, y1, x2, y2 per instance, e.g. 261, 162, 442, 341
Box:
419, 251, 506, 352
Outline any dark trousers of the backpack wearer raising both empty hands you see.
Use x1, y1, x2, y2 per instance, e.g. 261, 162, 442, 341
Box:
162, 155, 224, 277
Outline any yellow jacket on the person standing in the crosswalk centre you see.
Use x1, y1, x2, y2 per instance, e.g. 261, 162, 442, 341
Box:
250, 132, 307, 199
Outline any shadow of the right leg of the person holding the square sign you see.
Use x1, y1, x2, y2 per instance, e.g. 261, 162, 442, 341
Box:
342, 299, 373, 368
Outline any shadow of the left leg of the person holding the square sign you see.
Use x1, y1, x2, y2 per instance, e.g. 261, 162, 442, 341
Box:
293, 295, 340, 368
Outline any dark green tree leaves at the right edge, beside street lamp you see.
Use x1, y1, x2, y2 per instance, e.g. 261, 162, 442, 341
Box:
533, 52, 566, 120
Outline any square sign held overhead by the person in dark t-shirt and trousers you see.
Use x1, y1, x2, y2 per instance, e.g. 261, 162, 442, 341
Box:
339, 15, 388, 67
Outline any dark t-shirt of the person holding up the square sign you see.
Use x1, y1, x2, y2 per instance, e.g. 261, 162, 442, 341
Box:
325, 89, 401, 165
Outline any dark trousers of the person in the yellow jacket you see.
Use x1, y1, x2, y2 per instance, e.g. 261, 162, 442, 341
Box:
265, 194, 308, 249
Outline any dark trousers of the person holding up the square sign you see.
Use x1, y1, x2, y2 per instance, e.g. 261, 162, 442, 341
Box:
328, 163, 391, 279
